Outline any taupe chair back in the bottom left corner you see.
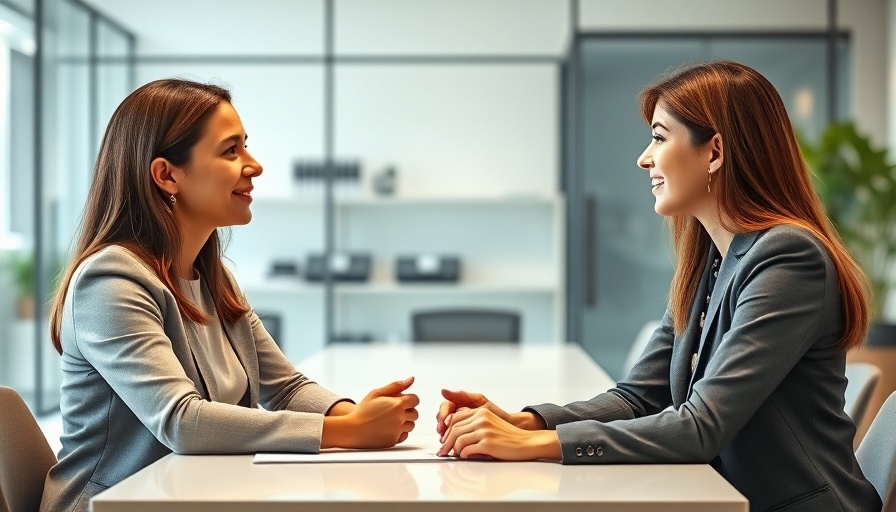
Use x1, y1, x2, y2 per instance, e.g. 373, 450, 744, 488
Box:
0, 386, 56, 512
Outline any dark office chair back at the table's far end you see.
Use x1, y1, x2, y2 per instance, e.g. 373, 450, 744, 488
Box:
411, 309, 520, 343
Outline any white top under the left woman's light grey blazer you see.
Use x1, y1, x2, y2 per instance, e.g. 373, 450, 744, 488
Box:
179, 278, 249, 405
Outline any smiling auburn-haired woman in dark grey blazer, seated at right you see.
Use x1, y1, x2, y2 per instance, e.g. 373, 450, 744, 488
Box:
437, 61, 881, 512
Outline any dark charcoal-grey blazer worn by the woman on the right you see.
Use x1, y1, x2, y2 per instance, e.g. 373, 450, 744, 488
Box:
529, 226, 881, 512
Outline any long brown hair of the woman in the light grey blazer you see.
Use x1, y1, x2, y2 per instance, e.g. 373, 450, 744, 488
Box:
50, 79, 249, 354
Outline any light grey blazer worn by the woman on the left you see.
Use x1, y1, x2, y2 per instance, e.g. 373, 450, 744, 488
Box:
41, 246, 342, 511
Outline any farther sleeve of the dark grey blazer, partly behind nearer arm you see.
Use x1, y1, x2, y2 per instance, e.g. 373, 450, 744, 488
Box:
524, 311, 675, 429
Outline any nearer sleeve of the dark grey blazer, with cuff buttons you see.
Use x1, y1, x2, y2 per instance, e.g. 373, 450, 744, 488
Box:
557, 231, 842, 464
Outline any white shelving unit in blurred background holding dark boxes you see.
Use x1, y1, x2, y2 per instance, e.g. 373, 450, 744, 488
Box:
228, 196, 565, 364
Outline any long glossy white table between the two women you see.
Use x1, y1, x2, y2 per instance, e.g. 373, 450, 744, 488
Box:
92, 344, 749, 512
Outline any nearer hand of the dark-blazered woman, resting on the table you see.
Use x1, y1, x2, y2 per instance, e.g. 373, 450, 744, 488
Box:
438, 407, 561, 461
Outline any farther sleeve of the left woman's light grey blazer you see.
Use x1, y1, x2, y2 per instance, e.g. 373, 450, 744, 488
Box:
248, 311, 354, 414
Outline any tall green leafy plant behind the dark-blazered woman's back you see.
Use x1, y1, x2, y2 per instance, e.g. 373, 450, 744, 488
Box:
800, 121, 896, 344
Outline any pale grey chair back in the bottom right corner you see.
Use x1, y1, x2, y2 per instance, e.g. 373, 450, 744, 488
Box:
856, 392, 896, 510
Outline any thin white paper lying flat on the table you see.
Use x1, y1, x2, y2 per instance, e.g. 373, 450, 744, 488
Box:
252, 443, 448, 464
